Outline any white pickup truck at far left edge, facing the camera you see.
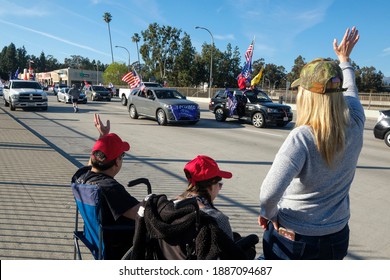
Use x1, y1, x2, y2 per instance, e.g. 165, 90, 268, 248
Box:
3, 80, 48, 111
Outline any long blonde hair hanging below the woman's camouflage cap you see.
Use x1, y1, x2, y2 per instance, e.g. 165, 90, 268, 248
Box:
295, 87, 349, 166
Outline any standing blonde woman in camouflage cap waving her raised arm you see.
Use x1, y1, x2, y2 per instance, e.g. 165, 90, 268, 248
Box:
258, 27, 365, 259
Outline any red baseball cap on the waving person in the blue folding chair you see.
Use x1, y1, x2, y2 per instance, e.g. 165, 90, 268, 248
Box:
92, 133, 130, 161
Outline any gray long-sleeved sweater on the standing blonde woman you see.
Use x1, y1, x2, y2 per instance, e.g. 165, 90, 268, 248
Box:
260, 62, 365, 236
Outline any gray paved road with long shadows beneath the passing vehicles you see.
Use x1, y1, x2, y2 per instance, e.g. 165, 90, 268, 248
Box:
1, 95, 390, 259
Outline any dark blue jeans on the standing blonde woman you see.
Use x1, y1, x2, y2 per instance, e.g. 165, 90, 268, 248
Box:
263, 223, 349, 260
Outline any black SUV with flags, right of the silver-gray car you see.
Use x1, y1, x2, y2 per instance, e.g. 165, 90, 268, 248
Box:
209, 89, 293, 128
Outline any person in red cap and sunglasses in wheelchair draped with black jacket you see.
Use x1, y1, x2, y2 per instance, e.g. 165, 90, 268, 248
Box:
124, 156, 259, 259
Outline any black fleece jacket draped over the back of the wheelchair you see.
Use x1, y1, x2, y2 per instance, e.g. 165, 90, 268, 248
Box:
131, 194, 246, 260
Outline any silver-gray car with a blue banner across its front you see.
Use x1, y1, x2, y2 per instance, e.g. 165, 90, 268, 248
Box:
127, 87, 200, 125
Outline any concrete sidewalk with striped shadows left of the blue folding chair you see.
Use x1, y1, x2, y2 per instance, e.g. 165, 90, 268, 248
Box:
0, 108, 75, 260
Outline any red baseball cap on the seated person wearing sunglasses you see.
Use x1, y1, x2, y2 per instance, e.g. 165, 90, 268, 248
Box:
184, 155, 233, 184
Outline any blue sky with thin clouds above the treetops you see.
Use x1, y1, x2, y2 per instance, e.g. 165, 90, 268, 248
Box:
0, 0, 390, 77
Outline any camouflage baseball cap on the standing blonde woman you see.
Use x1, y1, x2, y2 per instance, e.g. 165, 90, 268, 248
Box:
291, 58, 343, 93
